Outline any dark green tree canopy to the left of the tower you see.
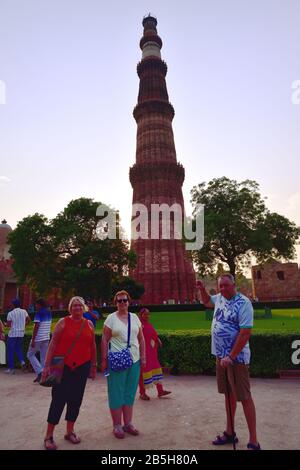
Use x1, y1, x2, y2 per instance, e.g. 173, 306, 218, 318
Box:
9, 198, 135, 300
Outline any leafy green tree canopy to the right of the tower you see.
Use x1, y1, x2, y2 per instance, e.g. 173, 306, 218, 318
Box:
191, 177, 300, 275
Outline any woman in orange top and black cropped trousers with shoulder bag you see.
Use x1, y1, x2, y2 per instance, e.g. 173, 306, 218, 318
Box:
41, 297, 97, 450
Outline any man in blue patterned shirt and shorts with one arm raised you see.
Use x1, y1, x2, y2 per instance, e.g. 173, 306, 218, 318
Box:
197, 274, 260, 450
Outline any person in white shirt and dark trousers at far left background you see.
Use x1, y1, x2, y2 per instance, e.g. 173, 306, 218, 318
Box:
5, 299, 30, 374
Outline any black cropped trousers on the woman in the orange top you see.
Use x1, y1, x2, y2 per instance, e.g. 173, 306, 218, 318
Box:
47, 361, 91, 425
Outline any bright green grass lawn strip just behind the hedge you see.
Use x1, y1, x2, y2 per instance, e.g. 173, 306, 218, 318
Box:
17, 309, 300, 333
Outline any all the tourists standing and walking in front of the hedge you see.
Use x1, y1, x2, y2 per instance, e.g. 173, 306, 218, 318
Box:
0, 274, 260, 450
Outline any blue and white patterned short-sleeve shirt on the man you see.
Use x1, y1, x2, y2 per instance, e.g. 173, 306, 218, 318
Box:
210, 293, 253, 364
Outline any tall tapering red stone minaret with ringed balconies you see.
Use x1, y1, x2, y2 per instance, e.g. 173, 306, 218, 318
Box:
130, 15, 195, 304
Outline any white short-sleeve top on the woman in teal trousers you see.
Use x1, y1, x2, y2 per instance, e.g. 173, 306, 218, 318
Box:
104, 312, 141, 362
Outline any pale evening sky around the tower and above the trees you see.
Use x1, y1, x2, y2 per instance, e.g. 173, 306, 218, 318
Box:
0, 0, 300, 264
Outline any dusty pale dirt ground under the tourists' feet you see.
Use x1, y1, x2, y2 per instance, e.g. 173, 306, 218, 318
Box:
0, 368, 300, 451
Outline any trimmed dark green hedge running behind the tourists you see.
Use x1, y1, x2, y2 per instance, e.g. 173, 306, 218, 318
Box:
3, 330, 300, 377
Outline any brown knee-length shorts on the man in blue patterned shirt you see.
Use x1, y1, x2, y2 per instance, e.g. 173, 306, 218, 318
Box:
216, 358, 251, 401
